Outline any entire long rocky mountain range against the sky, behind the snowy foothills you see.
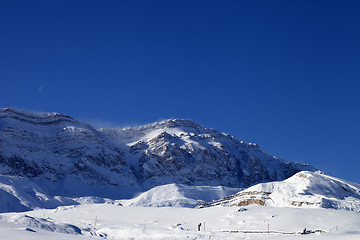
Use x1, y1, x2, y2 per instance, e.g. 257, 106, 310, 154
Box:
0, 108, 315, 198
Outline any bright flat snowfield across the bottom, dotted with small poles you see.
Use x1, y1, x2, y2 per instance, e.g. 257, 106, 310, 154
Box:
0, 204, 360, 240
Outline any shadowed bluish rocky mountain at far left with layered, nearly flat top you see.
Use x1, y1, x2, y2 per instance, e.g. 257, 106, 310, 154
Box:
0, 108, 136, 189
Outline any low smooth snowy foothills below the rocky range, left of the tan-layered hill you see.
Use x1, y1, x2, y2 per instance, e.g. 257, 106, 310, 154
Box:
0, 176, 240, 212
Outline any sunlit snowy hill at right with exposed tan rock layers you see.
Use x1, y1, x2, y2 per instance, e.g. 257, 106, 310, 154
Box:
198, 171, 360, 212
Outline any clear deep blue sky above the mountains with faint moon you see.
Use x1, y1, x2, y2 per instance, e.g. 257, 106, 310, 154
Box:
0, 0, 360, 183
